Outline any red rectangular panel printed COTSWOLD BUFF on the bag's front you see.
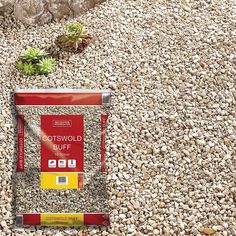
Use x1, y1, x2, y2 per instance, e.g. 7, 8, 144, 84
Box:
41, 115, 84, 172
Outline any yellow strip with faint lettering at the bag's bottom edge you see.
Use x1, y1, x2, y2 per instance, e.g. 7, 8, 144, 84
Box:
40, 213, 84, 226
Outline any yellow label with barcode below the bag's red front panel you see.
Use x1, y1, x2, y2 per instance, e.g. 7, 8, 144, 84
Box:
40, 172, 79, 189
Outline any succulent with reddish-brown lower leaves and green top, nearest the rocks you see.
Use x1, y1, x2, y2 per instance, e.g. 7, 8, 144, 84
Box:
56, 22, 92, 52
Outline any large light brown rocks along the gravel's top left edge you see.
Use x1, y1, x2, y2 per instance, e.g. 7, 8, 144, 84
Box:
0, 0, 104, 25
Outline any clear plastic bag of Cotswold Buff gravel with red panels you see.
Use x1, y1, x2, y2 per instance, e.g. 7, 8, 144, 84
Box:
14, 89, 111, 226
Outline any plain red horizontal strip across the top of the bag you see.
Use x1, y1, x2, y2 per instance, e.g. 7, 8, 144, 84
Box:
14, 92, 102, 106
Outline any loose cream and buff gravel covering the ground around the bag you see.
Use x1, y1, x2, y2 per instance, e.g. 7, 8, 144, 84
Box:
0, 0, 236, 236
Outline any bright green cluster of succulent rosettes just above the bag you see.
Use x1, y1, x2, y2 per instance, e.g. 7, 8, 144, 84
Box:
16, 48, 56, 75
